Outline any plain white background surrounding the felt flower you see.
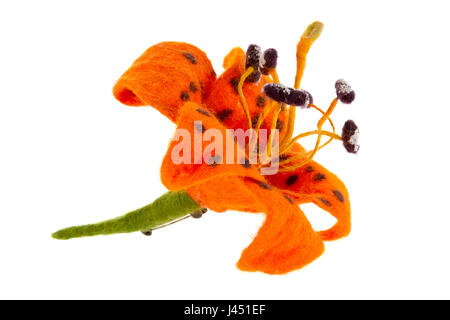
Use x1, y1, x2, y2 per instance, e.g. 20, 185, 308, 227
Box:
0, 0, 450, 299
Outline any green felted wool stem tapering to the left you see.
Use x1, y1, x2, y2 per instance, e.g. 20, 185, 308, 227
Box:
52, 191, 201, 240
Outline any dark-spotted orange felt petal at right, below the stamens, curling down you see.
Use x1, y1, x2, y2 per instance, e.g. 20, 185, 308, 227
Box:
266, 144, 351, 240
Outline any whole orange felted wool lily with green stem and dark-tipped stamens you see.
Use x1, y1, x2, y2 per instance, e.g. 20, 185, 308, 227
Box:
53, 22, 357, 274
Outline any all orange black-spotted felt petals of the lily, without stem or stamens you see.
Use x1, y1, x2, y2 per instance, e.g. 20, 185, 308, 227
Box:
114, 33, 351, 274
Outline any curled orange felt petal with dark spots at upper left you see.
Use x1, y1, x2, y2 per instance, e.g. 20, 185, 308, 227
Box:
113, 42, 216, 121
